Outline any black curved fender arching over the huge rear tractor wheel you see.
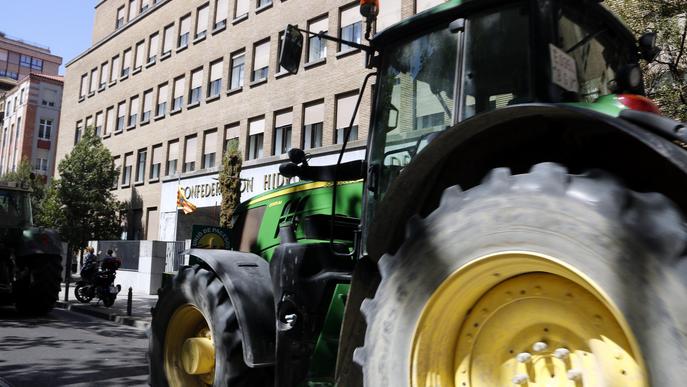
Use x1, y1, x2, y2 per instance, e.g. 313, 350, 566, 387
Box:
366, 104, 687, 261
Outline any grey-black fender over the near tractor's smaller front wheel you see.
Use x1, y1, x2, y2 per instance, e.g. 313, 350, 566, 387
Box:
188, 249, 276, 367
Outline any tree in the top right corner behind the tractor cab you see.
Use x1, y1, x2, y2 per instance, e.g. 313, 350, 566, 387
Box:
606, 0, 687, 121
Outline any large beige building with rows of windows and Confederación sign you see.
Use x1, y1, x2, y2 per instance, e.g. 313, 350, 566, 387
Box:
57, 0, 441, 240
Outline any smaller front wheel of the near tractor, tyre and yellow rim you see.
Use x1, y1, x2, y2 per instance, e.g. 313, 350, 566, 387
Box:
148, 265, 273, 387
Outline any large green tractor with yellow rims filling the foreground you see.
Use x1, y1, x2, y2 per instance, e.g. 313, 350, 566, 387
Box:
151, 0, 687, 387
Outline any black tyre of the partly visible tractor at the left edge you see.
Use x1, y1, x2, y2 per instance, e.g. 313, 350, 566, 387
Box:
14, 256, 62, 315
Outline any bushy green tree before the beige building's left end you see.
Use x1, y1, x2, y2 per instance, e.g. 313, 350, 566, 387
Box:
50, 127, 121, 248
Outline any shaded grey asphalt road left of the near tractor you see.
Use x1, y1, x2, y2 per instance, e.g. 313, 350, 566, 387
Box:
0, 307, 148, 387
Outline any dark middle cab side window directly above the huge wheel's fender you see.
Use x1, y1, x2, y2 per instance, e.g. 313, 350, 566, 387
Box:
462, 3, 533, 119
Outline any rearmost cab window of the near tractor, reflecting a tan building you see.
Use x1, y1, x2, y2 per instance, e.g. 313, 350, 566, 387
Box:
552, 2, 634, 102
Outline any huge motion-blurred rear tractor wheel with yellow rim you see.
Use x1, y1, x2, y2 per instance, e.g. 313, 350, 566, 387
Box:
354, 163, 687, 387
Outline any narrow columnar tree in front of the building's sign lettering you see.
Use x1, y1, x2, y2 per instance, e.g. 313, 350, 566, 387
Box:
219, 140, 242, 227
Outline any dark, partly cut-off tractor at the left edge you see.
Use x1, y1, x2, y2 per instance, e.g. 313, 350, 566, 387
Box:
0, 182, 62, 315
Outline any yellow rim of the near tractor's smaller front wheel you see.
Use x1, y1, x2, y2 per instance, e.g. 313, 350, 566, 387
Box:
164, 304, 215, 387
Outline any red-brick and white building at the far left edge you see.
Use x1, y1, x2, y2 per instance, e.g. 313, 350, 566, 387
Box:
0, 73, 63, 179
